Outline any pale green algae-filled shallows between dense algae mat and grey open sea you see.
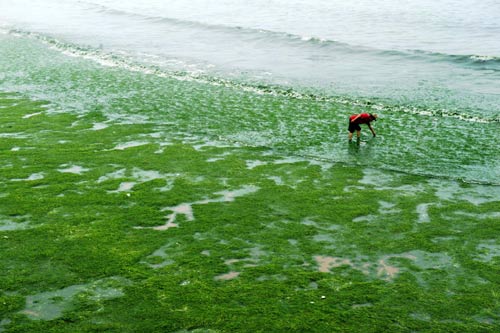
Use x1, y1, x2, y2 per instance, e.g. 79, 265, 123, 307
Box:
0, 34, 500, 184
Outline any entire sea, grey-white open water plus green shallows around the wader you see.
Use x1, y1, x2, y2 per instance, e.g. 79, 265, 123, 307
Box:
0, 0, 500, 186
